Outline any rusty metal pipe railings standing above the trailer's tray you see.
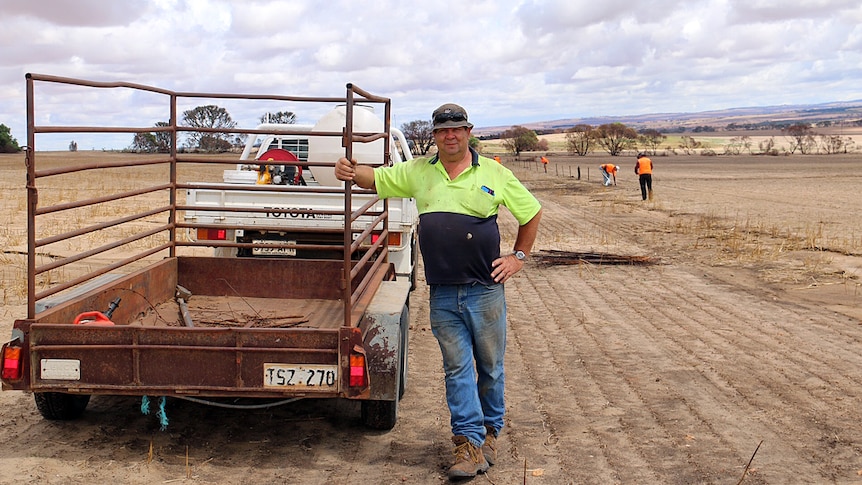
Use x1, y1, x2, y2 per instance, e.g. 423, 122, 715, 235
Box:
25, 73, 391, 326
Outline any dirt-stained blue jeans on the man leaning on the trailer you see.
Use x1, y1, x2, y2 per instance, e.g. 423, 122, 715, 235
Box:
430, 284, 506, 446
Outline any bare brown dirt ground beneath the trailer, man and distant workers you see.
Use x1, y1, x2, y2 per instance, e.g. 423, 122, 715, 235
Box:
0, 150, 862, 485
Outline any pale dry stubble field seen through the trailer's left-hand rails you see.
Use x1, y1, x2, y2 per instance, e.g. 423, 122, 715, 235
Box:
0, 152, 237, 304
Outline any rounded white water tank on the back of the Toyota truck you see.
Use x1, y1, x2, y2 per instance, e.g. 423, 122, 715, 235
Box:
308, 104, 383, 186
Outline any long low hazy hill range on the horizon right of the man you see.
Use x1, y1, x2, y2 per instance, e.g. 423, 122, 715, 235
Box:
473, 100, 862, 137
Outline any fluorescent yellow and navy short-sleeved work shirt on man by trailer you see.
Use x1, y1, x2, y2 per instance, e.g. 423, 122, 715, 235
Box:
374, 148, 542, 286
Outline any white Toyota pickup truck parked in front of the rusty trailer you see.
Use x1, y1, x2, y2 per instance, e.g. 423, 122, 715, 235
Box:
185, 106, 419, 288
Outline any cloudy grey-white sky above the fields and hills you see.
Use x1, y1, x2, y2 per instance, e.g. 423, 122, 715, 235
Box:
0, 0, 862, 149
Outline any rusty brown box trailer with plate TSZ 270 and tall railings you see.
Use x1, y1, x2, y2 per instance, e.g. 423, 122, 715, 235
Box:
0, 74, 415, 429
